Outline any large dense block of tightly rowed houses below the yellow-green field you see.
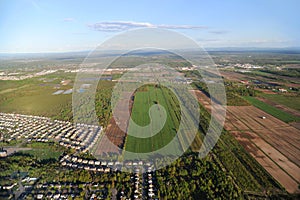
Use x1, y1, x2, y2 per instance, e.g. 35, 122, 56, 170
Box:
0, 113, 102, 152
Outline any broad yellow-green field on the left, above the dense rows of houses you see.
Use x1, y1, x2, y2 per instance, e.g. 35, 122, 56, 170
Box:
0, 73, 73, 120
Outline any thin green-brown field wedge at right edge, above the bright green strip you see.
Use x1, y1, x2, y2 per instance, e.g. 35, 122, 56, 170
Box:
261, 94, 300, 111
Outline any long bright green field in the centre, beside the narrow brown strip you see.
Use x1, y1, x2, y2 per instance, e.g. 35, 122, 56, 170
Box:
125, 85, 180, 153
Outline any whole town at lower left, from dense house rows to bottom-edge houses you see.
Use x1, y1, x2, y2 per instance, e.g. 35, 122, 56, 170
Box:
0, 113, 156, 199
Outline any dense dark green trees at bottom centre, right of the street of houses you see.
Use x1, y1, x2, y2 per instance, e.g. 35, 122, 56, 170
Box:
156, 154, 241, 199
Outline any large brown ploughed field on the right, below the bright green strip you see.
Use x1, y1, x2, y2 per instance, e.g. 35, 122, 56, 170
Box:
192, 91, 300, 193
